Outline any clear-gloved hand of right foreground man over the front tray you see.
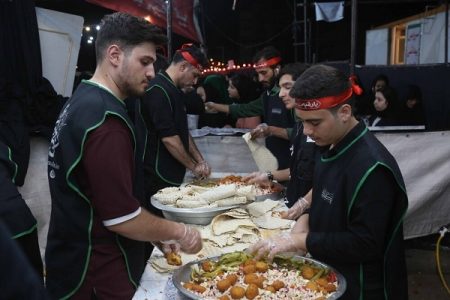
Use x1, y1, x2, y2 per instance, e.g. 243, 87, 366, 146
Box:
248, 233, 306, 262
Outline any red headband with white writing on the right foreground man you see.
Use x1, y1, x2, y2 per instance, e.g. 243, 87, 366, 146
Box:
295, 76, 362, 110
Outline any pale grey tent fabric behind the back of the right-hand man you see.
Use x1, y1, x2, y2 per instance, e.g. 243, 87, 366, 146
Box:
376, 131, 450, 239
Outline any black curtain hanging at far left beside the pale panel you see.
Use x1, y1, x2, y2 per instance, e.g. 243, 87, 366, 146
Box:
0, 0, 64, 185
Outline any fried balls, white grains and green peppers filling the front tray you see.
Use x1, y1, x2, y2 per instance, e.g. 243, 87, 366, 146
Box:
181, 252, 338, 300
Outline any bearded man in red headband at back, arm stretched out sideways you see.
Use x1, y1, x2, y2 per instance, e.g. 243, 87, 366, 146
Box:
206, 47, 295, 170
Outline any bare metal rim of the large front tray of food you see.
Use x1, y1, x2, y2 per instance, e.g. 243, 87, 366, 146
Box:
172, 255, 347, 300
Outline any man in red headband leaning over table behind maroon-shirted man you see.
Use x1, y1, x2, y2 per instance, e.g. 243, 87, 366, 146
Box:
142, 44, 211, 209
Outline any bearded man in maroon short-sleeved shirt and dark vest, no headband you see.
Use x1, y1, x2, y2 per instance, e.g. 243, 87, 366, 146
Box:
46, 13, 202, 299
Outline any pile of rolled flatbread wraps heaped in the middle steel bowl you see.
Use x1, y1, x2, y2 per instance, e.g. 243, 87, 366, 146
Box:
153, 183, 256, 208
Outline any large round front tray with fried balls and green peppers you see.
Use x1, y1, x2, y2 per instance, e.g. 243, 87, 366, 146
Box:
172, 252, 347, 300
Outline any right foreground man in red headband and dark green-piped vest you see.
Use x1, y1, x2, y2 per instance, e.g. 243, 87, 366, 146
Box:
250, 65, 408, 299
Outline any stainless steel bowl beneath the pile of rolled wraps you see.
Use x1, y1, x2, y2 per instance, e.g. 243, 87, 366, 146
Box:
150, 197, 238, 225
